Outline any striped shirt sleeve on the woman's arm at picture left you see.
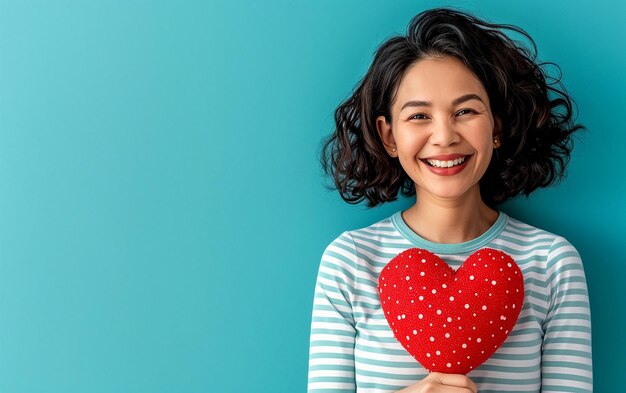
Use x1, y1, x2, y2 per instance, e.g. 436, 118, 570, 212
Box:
308, 232, 357, 393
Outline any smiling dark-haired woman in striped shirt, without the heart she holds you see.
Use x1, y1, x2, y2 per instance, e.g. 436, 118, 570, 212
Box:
308, 8, 592, 393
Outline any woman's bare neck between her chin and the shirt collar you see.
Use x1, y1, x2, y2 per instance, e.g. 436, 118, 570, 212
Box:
402, 187, 498, 243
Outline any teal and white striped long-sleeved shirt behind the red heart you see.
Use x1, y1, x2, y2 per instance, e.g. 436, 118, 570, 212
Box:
308, 211, 592, 393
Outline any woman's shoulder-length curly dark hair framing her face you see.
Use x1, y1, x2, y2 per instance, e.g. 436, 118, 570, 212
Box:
320, 8, 586, 207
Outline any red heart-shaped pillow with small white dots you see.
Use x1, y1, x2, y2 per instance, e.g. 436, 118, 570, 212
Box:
378, 248, 524, 374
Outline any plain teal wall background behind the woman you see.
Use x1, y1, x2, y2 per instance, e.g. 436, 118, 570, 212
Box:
0, 0, 626, 393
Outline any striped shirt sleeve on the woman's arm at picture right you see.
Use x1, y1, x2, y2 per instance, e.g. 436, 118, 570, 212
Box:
541, 237, 593, 393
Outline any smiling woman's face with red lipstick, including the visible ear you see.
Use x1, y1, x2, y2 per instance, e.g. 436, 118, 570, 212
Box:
376, 56, 494, 199
